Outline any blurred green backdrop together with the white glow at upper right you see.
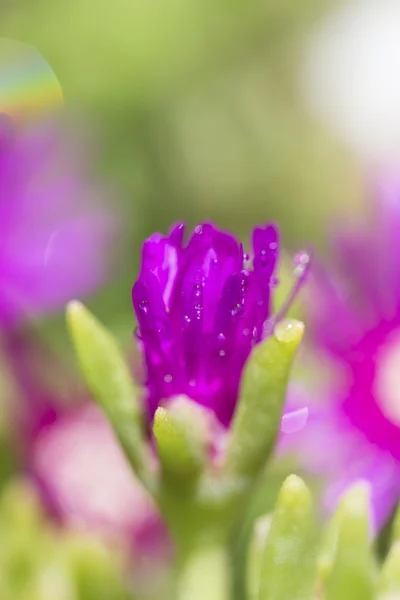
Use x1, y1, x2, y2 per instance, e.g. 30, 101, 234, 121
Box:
0, 0, 400, 596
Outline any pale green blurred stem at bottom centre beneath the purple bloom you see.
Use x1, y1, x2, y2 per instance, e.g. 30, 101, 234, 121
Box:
177, 546, 230, 600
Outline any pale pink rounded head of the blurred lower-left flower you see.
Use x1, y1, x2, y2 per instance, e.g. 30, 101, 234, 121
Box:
29, 402, 170, 568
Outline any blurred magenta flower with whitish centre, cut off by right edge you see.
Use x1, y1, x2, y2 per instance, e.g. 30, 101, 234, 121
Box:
282, 171, 400, 529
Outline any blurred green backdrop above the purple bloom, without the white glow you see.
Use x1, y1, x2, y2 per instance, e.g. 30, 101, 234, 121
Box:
0, 0, 361, 339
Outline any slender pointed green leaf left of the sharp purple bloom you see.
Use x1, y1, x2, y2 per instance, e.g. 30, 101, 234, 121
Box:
67, 301, 149, 487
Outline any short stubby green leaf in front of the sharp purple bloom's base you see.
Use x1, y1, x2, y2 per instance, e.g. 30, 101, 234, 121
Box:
153, 396, 208, 478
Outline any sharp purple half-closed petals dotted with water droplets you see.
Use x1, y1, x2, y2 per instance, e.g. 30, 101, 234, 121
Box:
132, 224, 309, 426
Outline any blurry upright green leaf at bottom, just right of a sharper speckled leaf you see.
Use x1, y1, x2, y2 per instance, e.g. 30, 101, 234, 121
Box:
326, 484, 376, 600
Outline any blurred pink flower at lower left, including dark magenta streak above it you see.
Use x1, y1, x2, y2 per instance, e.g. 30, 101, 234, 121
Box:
6, 328, 172, 581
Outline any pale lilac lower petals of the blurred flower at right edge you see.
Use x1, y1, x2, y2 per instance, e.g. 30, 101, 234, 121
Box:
279, 388, 400, 535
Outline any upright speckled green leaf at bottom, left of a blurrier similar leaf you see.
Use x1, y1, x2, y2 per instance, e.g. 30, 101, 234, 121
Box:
258, 475, 318, 600
